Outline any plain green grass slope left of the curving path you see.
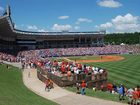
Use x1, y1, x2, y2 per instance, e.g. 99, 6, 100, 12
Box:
0, 65, 57, 105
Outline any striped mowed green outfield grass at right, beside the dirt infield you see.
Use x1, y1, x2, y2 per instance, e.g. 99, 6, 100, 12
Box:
69, 55, 140, 88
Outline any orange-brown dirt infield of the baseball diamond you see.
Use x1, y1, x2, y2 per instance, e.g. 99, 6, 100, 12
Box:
67, 55, 124, 63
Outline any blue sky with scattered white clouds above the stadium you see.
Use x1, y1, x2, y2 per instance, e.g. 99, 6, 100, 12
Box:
0, 0, 140, 33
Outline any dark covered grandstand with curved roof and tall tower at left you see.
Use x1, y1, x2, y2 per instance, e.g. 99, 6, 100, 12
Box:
0, 6, 105, 52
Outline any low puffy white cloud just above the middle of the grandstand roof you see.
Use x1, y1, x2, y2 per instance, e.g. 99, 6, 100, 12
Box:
52, 24, 72, 31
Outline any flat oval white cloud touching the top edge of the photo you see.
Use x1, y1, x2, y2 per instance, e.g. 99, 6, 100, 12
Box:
97, 0, 122, 8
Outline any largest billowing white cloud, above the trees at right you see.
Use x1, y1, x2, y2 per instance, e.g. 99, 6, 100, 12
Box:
95, 13, 140, 32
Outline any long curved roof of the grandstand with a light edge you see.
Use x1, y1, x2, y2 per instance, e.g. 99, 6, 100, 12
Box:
0, 15, 105, 37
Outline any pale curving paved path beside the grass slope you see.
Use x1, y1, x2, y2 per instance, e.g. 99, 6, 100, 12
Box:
4, 64, 125, 105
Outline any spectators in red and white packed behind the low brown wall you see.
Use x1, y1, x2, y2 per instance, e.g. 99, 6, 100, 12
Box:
37, 59, 106, 77
